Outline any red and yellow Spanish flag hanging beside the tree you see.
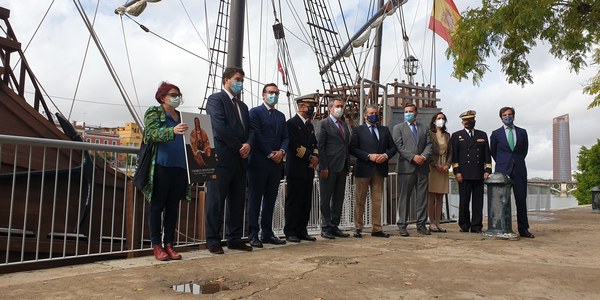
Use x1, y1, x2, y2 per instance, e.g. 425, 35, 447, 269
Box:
429, 0, 460, 45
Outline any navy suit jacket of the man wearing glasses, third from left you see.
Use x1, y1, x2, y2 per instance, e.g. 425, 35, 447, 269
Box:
249, 104, 289, 167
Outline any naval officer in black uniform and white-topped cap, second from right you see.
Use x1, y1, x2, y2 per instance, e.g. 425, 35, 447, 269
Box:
450, 110, 492, 233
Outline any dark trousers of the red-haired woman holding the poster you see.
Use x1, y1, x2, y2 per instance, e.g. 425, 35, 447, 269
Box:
148, 165, 187, 245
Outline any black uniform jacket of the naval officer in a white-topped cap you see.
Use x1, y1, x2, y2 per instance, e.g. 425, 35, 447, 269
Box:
450, 129, 492, 180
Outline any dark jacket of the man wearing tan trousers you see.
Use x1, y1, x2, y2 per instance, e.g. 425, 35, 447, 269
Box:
350, 124, 397, 177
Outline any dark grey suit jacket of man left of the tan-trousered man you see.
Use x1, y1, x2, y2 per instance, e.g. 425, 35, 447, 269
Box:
317, 117, 350, 172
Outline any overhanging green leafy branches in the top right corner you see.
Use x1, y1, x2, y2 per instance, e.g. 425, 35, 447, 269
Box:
446, 0, 600, 109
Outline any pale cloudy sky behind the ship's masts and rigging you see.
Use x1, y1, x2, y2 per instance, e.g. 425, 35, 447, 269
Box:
0, 0, 599, 178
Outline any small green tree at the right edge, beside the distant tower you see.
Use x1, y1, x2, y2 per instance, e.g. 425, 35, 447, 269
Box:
573, 139, 600, 204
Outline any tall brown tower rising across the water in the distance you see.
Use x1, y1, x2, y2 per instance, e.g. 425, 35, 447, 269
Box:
552, 114, 572, 181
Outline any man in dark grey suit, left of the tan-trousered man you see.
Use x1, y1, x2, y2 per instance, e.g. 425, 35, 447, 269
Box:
317, 98, 350, 239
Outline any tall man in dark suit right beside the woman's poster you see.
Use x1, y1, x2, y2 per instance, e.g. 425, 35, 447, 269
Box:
206, 67, 254, 254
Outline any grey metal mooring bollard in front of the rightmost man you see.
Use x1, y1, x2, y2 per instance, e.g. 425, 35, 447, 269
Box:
483, 173, 518, 239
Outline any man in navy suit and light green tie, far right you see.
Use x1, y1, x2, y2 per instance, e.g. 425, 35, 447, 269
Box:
490, 107, 534, 238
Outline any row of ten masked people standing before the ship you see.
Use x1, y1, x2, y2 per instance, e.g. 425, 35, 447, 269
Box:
144, 67, 533, 260
